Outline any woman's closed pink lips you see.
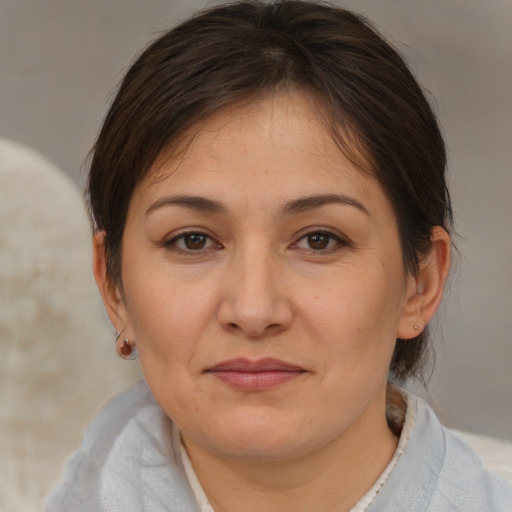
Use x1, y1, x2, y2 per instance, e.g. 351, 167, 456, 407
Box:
208, 358, 305, 391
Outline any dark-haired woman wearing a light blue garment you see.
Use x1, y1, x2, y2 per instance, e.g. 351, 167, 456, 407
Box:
48, 1, 512, 512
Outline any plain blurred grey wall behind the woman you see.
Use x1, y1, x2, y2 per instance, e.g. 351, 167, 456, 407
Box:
0, 0, 512, 440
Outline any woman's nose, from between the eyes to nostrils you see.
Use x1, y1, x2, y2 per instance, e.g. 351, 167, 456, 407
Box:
218, 248, 293, 340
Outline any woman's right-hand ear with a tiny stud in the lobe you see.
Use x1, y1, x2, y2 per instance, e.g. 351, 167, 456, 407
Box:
397, 226, 451, 339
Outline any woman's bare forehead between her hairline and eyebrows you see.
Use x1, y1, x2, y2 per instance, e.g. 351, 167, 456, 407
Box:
136, 92, 381, 214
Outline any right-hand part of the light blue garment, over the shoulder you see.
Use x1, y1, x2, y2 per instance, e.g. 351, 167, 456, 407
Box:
368, 394, 512, 512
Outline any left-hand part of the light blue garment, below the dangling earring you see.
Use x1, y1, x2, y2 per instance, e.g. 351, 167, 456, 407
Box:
47, 382, 198, 512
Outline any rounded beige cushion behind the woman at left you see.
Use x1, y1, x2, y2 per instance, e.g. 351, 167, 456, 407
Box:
0, 139, 140, 512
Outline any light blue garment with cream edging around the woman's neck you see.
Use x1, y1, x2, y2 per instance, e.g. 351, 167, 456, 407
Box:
47, 382, 512, 512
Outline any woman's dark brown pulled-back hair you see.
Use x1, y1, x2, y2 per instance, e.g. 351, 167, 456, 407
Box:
87, 0, 451, 379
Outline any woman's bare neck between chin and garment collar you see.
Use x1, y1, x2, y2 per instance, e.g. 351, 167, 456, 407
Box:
184, 388, 397, 512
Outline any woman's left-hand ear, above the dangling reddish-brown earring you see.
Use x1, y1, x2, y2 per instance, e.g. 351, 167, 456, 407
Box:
92, 231, 130, 337
